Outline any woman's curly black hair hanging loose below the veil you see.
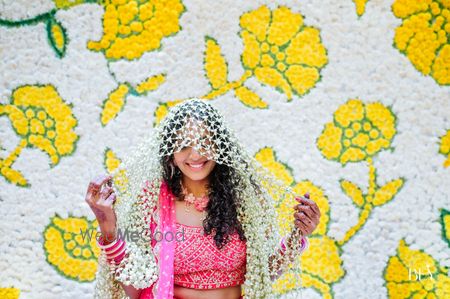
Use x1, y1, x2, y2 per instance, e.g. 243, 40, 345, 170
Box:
161, 154, 246, 249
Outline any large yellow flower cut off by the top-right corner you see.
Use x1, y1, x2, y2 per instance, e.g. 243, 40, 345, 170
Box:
392, 0, 450, 85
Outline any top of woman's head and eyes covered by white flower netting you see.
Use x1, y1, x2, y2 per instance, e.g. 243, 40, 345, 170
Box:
159, 98, 238, 166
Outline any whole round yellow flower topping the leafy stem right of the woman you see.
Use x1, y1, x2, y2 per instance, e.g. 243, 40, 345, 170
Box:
316, 99, 396, 165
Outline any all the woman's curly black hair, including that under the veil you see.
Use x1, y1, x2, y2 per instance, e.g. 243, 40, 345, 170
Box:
160, 101, 256, 249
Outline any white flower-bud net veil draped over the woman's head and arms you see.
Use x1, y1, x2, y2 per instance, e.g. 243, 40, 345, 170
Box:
95, 98, 301, 299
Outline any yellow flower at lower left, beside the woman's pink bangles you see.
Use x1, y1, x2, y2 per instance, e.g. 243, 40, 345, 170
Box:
43, 215, 100, 282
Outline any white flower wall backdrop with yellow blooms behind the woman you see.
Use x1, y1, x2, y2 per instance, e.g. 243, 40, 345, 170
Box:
0, 0, 450, 298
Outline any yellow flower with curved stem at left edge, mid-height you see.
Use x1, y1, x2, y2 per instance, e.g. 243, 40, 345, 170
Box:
0, 85, 78, 186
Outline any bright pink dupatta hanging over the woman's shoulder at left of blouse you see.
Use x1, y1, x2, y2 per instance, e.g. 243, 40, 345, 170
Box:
139, 181, 176, 299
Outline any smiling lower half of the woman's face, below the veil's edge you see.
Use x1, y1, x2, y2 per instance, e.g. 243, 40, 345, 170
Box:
173, 146, 216, 181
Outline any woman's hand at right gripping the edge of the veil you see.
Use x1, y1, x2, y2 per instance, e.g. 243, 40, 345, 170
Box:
294, 193, 320, 236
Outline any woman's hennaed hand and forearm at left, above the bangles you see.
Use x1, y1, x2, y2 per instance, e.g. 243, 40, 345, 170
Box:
85, 175, 117, 243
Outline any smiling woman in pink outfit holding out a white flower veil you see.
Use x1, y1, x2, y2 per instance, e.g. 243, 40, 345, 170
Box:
85, 98, 320, 299
